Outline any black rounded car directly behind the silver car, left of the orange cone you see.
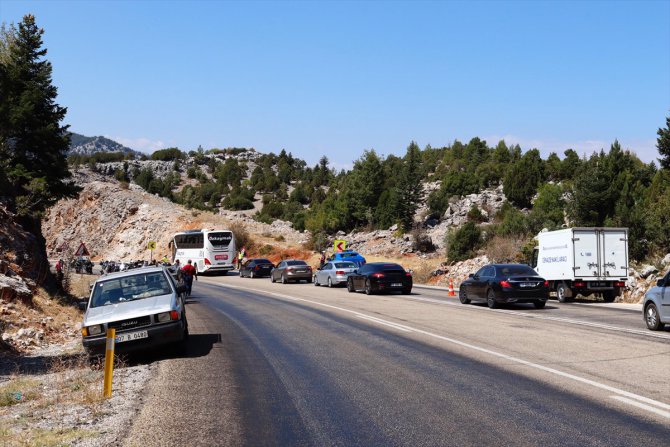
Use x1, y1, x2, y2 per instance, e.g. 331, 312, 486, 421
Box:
347, 262, 412, 295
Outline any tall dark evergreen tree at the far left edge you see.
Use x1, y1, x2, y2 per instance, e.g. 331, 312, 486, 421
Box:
0, 14, 77, 224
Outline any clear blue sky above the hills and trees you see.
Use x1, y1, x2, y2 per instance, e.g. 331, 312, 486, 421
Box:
0, 0, 670, 167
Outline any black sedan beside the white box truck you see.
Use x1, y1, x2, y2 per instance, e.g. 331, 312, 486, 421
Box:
459, 264, 549, 309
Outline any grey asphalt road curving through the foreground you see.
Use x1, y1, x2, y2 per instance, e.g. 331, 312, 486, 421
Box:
125, 276, 670, 446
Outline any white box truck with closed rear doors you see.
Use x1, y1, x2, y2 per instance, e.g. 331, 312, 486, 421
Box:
531, 228, 628, 303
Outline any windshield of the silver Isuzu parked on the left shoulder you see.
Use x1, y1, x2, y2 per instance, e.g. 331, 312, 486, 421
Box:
91, 272, 172, 307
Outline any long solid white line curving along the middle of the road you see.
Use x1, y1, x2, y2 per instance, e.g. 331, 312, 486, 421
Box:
205, 284, 670, 418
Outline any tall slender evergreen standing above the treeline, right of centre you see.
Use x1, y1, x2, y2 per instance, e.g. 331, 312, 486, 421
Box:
396, 141, 422, 232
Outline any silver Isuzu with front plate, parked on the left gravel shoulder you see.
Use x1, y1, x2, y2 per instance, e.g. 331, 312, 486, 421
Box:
81, 266, 188, 357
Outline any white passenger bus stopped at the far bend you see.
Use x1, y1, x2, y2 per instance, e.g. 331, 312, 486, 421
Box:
171, 230, 237, 273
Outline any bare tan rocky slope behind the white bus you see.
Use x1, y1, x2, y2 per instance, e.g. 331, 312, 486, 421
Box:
42, 170, 307, 260
